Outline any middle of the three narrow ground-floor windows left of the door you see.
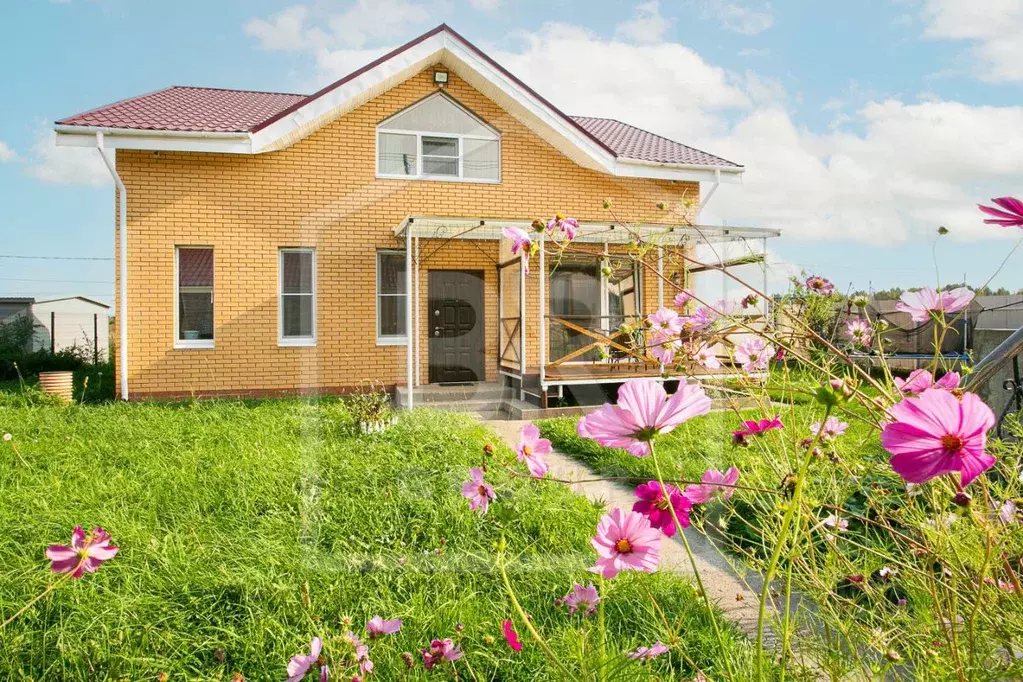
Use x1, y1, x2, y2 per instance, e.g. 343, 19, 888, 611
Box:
278, 248, 316, 346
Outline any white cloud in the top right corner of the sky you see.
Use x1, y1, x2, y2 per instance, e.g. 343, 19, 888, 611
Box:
922, 0, 1023, 83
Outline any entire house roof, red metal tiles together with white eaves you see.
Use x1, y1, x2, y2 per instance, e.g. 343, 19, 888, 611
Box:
56, 24, 744, 181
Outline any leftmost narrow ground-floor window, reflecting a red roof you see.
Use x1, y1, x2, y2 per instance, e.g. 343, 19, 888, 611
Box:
174, 246, 213, 348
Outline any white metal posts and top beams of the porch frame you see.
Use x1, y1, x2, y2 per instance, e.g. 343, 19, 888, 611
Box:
393, 216, 782, 409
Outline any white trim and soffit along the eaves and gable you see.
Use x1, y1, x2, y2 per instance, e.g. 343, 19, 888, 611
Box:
55, 27, 745, 182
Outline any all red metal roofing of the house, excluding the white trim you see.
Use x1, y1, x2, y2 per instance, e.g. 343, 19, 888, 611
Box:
57, 24, 742, 168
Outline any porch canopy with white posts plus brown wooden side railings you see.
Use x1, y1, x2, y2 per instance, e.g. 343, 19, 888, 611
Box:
394, 216, 782, 398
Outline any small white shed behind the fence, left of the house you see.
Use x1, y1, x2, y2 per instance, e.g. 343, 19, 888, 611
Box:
32, 297, 110, 362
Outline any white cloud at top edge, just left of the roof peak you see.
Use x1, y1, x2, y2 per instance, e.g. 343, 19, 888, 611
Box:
244, 0, 438, 51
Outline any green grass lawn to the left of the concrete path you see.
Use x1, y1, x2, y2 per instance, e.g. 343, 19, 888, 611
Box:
0, 396, 750, 681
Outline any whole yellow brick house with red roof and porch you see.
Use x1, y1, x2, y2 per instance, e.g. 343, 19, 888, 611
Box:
56, 25, 777, 398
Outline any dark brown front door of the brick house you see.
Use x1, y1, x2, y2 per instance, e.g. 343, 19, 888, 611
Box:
429, 270, 484, 383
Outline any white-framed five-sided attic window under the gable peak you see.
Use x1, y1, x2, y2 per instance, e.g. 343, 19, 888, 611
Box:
376, 93, 501, 182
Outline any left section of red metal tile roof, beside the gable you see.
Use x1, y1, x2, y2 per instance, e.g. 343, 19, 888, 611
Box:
57, 86, 306, 133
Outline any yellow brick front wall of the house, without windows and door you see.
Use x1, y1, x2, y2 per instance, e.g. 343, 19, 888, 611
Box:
115, 67, 699, 397
